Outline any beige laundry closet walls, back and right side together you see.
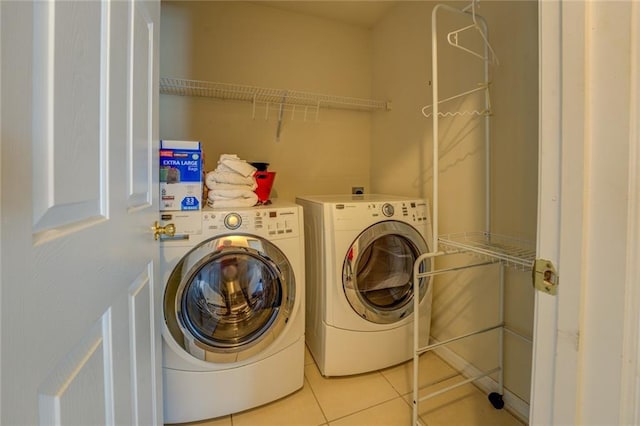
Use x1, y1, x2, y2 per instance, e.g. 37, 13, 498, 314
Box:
160, 1, 538, 412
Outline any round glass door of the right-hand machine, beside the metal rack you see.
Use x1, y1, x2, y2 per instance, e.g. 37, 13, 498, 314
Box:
342, 221, 431, 324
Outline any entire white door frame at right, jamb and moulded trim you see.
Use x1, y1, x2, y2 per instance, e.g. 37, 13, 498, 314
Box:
529, 0, 640, 425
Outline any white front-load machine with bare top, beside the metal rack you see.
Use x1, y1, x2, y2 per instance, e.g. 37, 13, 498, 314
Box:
296, 194, 432, 376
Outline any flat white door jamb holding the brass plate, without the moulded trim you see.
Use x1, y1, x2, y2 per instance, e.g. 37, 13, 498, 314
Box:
529, 0, 585, 425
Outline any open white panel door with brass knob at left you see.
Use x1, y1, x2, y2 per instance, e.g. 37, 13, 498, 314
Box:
0, 1, 162, 425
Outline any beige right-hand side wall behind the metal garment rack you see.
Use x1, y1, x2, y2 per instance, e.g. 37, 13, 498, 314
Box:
371, 1, 538, 401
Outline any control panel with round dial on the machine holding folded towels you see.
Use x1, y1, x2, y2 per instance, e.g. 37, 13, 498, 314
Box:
202, 206, 301, 239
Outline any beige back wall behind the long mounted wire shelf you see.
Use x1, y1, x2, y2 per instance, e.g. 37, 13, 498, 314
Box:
160, 1, 371, 201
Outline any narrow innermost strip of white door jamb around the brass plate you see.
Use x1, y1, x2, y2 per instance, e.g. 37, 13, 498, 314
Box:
529, 1, 564, 425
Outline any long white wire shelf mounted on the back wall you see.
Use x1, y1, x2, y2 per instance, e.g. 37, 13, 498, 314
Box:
160, 77, 390, 111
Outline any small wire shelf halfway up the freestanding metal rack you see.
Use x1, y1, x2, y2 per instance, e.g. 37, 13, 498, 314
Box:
438, 232, 536, 271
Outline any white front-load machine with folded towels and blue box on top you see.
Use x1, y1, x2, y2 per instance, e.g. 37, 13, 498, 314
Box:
161, 203, 305, 423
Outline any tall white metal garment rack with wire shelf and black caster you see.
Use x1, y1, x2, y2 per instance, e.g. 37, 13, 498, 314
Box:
412, 0, 536, 425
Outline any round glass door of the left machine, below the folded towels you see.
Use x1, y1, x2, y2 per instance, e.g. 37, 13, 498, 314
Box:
164, 235, 295, 363
